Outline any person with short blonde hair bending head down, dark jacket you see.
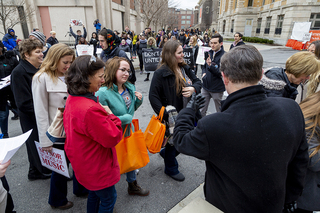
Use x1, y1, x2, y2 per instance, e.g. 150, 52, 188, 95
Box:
260, 51, 320, 100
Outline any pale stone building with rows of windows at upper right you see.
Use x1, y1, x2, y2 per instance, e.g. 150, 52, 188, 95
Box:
218, 0, 320, 45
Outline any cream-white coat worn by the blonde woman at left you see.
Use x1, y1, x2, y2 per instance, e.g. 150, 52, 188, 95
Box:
32, 73, 68, 147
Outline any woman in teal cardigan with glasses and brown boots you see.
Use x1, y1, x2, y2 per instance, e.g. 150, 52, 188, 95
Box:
96, 57, 149, 196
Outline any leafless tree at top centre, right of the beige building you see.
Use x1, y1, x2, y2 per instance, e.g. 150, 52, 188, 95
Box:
137, 0, 177, 27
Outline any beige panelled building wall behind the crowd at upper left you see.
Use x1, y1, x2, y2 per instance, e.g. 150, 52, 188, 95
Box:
0, 0, 144, 43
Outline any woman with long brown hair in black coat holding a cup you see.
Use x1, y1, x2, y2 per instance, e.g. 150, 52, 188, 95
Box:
149, 41, 201, 181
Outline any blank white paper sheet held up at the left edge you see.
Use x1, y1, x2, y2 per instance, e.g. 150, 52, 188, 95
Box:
0, 129, 32, 164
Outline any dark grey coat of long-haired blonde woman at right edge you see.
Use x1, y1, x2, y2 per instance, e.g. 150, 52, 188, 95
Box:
298, 126, 320, 211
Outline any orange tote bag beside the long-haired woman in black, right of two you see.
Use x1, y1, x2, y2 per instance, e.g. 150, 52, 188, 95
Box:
144, 107, 166, 154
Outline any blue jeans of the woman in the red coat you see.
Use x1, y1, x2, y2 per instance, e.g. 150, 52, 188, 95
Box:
87, 185, 117, 213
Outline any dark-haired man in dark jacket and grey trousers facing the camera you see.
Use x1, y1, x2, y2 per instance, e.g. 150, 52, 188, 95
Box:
201, 34, 225, 117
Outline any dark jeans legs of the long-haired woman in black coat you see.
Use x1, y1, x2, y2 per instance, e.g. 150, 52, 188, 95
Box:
160, 144, 180, 176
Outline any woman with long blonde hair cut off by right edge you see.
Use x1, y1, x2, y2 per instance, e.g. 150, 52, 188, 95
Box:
295, 92, 320, 213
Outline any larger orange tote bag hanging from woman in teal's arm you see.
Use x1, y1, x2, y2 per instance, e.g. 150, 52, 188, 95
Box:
116, 119, 150, 174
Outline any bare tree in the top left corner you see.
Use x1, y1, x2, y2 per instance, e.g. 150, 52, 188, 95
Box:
0, 0, 35, 34
